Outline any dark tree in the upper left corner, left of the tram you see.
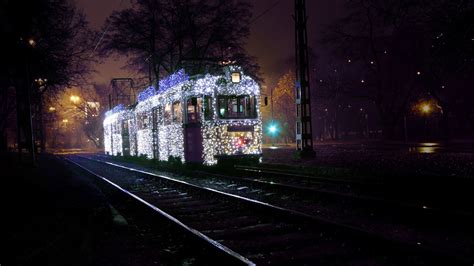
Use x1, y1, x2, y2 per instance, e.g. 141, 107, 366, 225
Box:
0, 0, 95, 150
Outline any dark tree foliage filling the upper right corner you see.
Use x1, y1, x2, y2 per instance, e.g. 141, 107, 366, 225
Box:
324, 0, 474, 138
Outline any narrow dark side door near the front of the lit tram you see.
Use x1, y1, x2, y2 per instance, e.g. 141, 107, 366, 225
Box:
184, 97, 203, 163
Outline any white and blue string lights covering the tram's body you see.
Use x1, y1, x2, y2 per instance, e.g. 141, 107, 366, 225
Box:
104, 66, 262, 165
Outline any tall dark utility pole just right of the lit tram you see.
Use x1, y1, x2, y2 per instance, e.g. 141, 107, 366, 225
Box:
293, 0, 314, 156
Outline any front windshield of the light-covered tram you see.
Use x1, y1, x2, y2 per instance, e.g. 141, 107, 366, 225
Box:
217, 95, 257, 119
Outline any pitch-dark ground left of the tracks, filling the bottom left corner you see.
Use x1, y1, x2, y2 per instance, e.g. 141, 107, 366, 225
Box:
0, 154, 206, 265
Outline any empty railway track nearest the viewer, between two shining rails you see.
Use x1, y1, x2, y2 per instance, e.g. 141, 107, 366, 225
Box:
65, 156, 460, 265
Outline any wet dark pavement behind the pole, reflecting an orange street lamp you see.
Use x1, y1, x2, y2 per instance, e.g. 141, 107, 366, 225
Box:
263, 142, 474, 181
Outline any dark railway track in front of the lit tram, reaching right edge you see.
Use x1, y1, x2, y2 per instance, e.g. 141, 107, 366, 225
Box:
207, 166, 474, 261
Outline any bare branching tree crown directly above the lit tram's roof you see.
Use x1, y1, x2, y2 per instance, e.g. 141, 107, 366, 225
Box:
102, 0, 258, 83
